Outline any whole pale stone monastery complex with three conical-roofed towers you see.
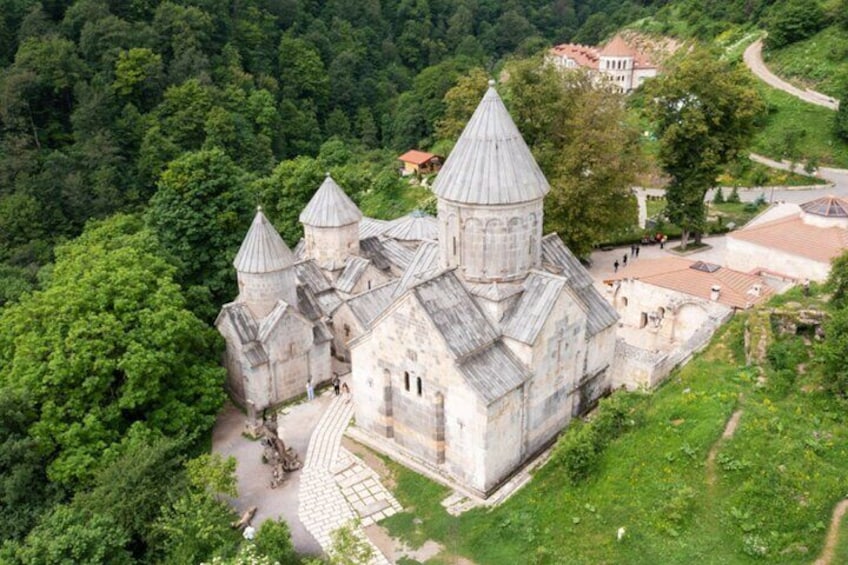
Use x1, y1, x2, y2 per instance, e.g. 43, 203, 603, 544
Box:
216, 82, 618, 496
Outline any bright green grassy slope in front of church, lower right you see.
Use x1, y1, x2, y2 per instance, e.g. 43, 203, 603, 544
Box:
383, 292, 848, 565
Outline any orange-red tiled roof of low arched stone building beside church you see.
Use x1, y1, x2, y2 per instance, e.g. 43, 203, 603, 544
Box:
608, 257, 774, 308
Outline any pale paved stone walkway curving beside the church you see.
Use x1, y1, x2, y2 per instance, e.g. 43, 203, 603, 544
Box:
298, 396, 401, 565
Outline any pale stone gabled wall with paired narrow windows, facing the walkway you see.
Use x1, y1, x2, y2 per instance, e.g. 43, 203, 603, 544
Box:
351, 295, 487, 491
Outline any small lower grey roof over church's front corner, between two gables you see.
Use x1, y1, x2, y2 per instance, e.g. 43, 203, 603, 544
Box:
459, 340, 529, 404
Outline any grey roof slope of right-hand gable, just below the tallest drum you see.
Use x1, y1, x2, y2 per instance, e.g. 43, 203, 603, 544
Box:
503, 273, 565, 345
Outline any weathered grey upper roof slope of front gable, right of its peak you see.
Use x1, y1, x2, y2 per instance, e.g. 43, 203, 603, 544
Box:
412, 271, 498, 358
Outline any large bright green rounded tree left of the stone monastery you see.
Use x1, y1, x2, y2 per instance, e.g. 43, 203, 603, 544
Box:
0, 216, 224, 485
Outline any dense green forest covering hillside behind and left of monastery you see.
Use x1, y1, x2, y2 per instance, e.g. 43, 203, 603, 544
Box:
0, 0, 840, 563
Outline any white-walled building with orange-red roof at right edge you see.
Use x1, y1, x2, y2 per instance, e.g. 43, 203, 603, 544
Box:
725, 196, 848, 281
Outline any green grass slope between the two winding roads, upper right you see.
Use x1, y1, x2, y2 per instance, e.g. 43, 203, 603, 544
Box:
752, 85, 848, 167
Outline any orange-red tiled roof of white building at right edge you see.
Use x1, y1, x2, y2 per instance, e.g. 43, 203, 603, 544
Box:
727, 216, 848, 267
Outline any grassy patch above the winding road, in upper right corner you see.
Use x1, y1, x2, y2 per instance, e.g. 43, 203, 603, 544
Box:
763, 26, 848, 98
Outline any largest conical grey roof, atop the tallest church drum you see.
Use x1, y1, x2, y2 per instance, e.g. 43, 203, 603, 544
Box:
433, 83, 550, 204
